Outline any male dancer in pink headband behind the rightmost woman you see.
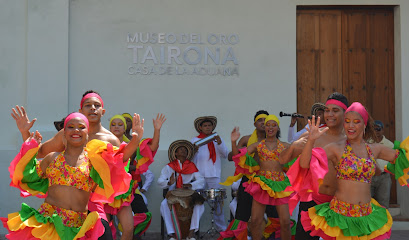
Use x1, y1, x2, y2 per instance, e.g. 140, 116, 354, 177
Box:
280, 92, 348, 240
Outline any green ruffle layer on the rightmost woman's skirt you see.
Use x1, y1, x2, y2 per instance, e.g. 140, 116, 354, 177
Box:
314, 202, 388, 237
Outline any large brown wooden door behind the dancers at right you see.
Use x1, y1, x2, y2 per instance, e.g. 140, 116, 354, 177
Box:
297, 7, 396, 203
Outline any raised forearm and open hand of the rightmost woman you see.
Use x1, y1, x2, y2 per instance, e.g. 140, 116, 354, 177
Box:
300, 116, 328, 168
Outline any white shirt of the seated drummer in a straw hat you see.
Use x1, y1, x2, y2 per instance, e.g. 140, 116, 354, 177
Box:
158, 160, 205, 190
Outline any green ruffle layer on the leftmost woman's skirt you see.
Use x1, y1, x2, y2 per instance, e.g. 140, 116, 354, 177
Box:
19, 203, 81, 240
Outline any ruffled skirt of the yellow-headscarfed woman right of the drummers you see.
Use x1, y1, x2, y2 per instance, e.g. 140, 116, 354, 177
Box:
243, 170, 295, 205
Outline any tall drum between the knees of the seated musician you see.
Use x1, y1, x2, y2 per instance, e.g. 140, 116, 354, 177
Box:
166, 188, 204, 239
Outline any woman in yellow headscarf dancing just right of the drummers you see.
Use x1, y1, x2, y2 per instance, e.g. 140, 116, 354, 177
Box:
231, 115, 294, 240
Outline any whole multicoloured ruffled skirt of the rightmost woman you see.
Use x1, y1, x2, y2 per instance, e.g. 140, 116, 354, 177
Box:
301, 197, 392, 240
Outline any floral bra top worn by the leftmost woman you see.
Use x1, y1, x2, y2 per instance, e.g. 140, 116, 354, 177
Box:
46, 151, 95, 192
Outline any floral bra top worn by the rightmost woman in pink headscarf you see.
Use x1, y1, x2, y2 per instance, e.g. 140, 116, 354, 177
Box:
336, 141, 376, 183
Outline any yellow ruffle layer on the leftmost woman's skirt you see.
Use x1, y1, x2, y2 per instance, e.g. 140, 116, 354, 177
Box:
7, 212, 99, 240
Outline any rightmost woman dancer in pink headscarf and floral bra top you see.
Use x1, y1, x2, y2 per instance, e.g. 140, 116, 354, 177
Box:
300, 102, 409, 240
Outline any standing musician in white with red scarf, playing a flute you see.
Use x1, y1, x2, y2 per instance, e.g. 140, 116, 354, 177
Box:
191, 116, 229, 232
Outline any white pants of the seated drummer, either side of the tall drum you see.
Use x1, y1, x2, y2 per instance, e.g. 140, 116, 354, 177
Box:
160, 199, 204, 235
